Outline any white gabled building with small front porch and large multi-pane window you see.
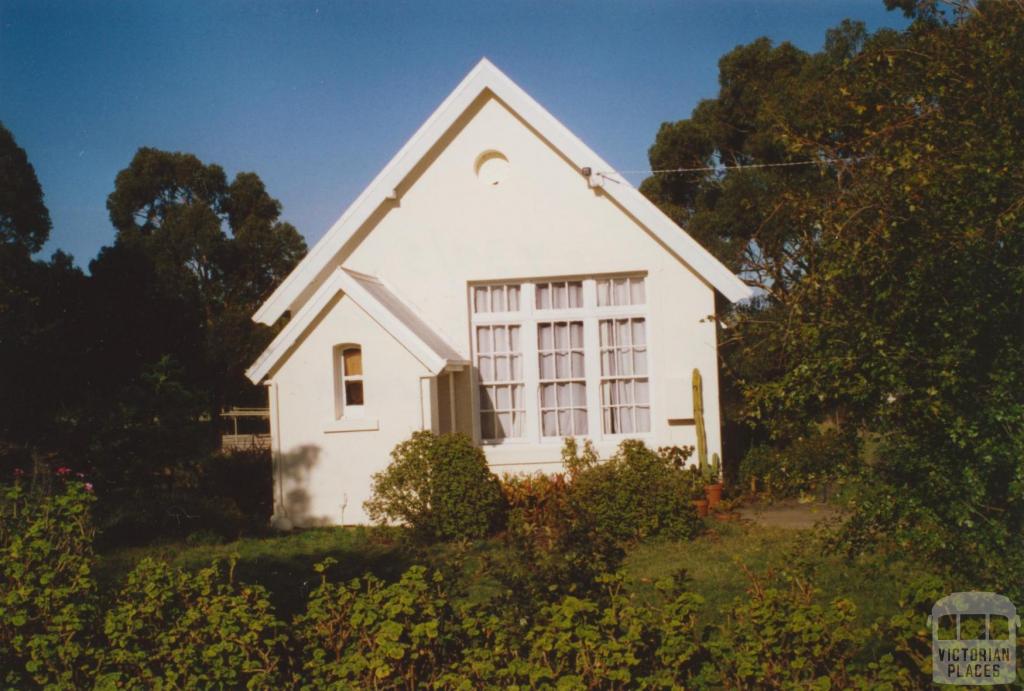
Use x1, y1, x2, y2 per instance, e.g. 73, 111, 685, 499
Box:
248, 59, 751, 525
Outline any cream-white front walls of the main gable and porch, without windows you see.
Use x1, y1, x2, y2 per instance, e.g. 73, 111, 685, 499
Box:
271, 95, 721, 522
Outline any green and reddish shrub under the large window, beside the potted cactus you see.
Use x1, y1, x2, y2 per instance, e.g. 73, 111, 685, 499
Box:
494, 438, 700, 603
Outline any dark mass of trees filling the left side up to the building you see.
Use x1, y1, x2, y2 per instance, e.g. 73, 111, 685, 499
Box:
0, 138, 305, 542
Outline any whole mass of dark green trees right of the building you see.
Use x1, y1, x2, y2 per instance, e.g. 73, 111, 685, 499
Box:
644, 2, 1024, 593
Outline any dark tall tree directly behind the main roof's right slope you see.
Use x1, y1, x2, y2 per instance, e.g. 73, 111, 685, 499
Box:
641, 31, 881, 464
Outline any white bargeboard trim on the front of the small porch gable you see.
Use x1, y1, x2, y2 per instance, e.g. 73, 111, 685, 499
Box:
246, 267, 469, 384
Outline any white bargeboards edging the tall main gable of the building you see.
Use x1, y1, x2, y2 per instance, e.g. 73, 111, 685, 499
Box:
253, 58, 753, 325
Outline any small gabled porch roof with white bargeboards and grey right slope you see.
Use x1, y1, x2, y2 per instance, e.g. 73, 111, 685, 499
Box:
246, 267, 469, 384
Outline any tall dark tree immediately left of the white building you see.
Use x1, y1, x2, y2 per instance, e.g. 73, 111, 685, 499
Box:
54, 148, 305, 542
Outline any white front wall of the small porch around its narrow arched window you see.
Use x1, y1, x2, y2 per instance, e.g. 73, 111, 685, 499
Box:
270, 296, 429, 525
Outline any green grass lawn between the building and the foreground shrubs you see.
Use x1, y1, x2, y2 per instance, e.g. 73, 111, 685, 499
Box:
97, 507, 909, 623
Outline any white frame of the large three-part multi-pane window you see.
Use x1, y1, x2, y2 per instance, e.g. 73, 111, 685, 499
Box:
468, 271, 657, 446
